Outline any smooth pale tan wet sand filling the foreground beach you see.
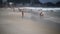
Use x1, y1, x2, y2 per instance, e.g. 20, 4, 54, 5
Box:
0, 7, 60, 34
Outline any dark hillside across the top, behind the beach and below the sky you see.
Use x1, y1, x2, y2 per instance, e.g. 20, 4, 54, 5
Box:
0, 0, 60, 7
